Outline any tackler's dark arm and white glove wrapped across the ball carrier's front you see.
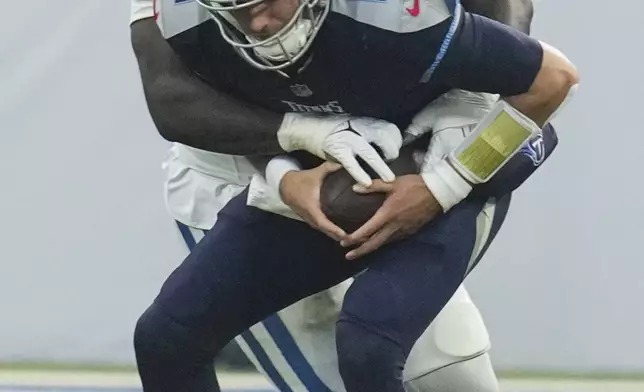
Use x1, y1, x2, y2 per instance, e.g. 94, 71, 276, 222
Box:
131, 16, 402, 186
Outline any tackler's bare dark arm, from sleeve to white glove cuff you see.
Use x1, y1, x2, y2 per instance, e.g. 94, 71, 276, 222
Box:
131, 18, 284, 155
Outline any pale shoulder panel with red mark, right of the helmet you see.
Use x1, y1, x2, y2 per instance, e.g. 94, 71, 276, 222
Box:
332, 0, 452, 33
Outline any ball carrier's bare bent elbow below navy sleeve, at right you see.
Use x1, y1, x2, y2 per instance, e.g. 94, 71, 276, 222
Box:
506, 42, 580, 126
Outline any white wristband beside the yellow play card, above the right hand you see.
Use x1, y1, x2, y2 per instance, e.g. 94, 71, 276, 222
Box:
420, 159, 472, 212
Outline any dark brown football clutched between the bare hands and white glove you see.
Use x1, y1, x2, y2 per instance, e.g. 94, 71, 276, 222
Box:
320, 147, 418, 233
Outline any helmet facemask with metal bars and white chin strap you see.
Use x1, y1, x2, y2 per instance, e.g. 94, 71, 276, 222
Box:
197, 0, 331, 74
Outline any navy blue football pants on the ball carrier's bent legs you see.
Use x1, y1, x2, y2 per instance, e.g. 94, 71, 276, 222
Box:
134, 192, 507, 392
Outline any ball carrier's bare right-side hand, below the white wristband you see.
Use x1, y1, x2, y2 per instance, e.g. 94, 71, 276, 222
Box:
341, 175, 443, 260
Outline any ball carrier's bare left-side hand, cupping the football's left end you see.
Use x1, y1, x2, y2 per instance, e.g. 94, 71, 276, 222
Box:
279, 162, 346, 241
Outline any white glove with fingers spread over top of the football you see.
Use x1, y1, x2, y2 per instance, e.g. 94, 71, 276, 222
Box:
277, 113, 402, 187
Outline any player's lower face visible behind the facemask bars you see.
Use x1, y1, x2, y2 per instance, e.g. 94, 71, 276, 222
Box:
231, 0, 300, 40
